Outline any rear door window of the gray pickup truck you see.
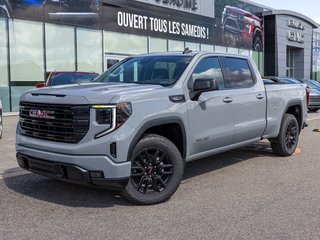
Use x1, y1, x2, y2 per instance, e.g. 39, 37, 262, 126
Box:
221, 57, 254, 88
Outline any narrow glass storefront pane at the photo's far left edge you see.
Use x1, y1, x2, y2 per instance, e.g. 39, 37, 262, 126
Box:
0, 18, 10, 112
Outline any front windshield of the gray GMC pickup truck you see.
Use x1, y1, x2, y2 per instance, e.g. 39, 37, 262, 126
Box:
94, 56, 192, 86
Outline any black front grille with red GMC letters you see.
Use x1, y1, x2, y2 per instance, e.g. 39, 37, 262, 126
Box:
19, 102, 90, 143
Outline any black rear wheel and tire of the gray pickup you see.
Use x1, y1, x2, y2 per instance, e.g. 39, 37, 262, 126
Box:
270, 114, 300, 156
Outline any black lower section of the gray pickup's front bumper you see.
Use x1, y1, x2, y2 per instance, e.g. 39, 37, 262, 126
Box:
17, 153, 129, 190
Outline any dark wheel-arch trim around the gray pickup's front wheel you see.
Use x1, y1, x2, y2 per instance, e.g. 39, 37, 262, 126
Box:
127, 117, 187, 161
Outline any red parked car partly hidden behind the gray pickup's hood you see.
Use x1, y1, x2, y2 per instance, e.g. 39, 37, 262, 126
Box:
36, 72, 99, 88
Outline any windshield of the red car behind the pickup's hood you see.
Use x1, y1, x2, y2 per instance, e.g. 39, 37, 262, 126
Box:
50, 73, 98, 86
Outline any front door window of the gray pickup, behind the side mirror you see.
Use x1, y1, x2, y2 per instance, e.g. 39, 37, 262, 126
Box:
192, 57, 224, 89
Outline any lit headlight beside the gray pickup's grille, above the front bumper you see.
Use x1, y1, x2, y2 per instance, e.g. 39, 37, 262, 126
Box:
92, 103, 132, 138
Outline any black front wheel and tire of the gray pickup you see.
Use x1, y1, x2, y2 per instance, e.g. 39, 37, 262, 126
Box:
123, 134, 185, 205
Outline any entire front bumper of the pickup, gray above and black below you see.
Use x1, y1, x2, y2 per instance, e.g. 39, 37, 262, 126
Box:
16, 143, 131, 188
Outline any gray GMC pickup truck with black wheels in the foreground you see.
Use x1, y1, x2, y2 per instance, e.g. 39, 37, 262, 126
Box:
16, 52, 307, 204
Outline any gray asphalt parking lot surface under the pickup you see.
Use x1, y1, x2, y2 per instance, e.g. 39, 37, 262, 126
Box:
0, 113, 320, 239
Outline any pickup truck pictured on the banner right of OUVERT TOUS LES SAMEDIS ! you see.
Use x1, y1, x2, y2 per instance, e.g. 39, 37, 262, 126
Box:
221, 5, 263, 51
